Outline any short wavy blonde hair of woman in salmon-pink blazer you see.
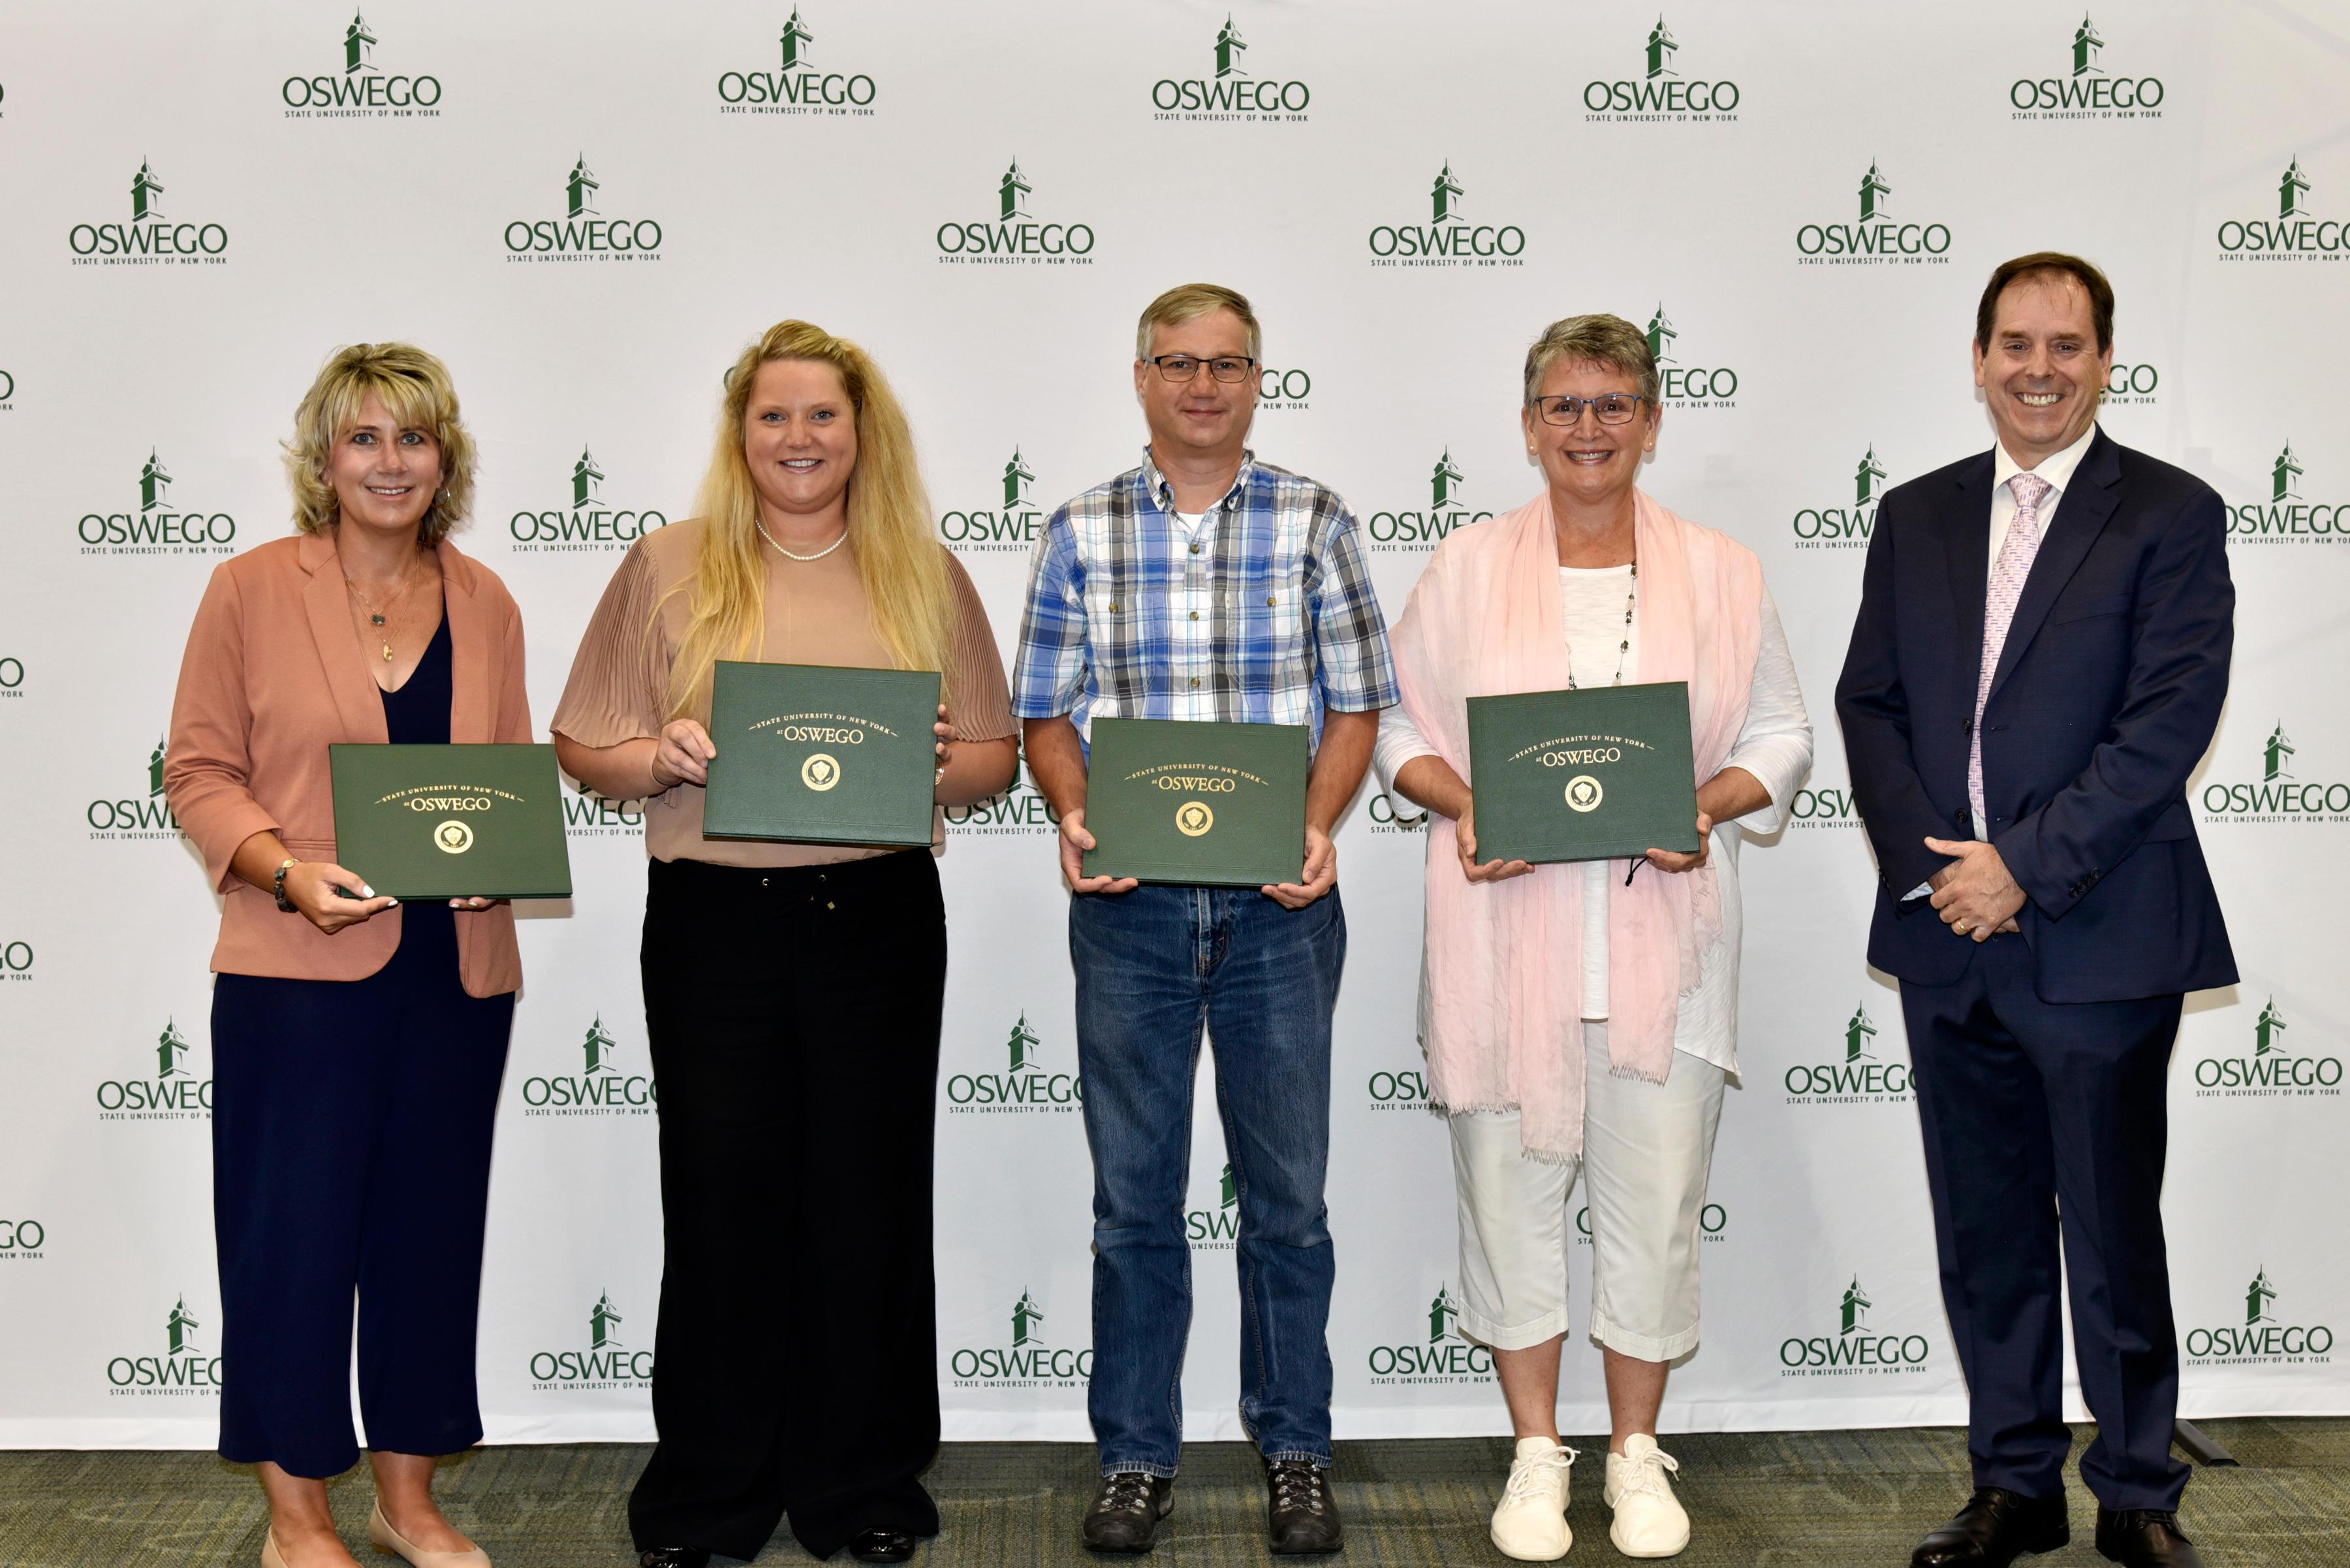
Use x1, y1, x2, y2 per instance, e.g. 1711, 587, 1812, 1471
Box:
285, 343, 475, 545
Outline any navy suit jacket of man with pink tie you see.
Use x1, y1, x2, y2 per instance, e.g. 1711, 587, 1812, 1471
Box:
1836, 430, 2235, 1001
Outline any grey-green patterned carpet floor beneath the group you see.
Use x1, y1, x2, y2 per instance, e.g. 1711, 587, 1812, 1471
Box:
0, 1420, 2350, 1568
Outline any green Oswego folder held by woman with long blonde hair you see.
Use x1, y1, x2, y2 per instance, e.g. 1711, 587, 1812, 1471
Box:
702, 658, 937, 844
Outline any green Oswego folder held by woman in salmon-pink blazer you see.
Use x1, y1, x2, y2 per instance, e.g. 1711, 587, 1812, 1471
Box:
326, 745, 571, 898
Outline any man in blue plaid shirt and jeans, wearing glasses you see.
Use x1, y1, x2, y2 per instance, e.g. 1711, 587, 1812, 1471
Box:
1013, 285, 1396, 1552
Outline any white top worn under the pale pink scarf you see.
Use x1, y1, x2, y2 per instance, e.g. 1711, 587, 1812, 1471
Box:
1372, 567, 1812, 1072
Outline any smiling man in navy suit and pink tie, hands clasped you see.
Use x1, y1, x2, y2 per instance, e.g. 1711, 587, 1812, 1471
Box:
1836, 251, 2235, 1568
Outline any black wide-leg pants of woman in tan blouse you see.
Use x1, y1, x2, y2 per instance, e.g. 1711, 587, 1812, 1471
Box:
627, 851, 947, 1559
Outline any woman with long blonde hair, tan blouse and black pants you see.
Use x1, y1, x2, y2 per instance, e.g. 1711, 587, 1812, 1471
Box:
552, 322, 1018, 1568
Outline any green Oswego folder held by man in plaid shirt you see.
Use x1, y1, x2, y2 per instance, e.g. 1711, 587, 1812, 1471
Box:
1086, 719, 1307, 886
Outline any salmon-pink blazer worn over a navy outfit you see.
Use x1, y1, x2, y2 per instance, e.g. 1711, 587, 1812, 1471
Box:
162, 533, 531, 997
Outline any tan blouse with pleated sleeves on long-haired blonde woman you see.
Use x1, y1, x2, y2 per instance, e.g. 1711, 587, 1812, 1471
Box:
548, 520, 1020, 865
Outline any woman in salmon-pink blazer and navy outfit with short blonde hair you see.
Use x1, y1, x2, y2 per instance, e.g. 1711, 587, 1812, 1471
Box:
164, 343, 531, 1568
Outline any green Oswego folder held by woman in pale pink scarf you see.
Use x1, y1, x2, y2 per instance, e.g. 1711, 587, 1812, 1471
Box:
1469, 682, 1697, 865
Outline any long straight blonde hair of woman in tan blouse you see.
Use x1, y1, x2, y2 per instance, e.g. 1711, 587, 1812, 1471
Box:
646, 322, 961, 722
